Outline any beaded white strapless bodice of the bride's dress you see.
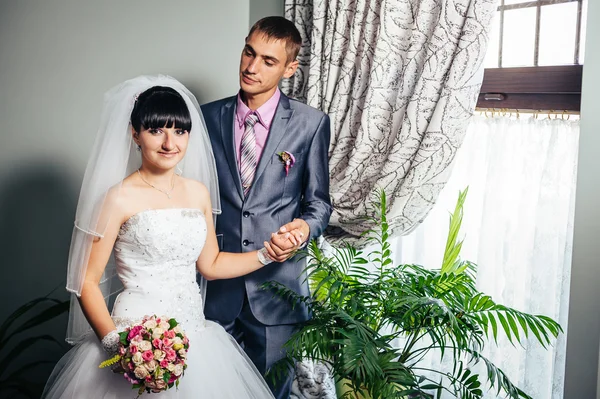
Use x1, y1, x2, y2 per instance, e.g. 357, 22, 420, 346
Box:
112, 208, 206, 329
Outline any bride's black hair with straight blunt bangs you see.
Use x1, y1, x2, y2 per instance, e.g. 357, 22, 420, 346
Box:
131, 86, 192, 132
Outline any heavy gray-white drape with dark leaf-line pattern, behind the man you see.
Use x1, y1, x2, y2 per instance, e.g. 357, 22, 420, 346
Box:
283, 0, 497, 245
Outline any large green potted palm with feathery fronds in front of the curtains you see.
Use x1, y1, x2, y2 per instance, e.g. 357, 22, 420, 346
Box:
266, 190, 562, 399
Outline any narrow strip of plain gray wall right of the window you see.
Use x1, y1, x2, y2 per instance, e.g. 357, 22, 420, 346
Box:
564, 0, 600, 399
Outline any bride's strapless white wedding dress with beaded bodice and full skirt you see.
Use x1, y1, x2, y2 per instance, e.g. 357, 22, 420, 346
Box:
43, 208, 273, 399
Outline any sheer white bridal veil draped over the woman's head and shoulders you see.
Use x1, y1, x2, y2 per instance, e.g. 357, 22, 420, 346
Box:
66, 75, 221, 344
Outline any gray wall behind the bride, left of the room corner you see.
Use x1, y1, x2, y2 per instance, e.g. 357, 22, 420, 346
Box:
0, 0, 250, 396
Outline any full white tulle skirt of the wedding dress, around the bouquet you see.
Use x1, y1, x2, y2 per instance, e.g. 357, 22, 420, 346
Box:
42, 321, 273, 399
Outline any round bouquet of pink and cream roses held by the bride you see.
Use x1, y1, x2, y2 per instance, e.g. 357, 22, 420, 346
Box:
100, 316, 190, 395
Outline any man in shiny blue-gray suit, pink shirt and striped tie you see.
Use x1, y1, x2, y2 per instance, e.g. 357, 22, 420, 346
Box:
202, 17, 331, 399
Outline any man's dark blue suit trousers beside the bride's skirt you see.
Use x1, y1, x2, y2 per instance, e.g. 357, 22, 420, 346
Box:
214, 293, 298, 399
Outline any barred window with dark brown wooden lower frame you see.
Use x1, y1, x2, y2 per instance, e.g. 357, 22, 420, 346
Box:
477, 0, 587, 111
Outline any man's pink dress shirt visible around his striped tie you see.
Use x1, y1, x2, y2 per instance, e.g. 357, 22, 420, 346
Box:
234, 89, 281, 168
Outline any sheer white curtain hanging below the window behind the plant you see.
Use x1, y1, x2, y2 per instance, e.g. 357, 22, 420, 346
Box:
395, 116, 579, 399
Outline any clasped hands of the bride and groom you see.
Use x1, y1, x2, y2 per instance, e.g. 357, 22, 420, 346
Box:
264, 219, 310, 262
